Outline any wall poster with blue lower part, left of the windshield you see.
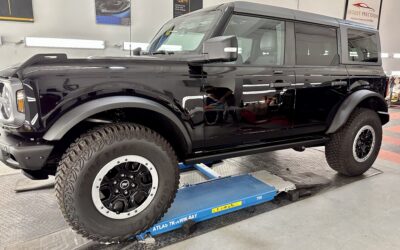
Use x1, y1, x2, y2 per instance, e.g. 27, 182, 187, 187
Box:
95, 0, 131, 26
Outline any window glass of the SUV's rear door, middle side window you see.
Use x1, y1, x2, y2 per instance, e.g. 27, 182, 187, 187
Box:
295, 23, 339, 66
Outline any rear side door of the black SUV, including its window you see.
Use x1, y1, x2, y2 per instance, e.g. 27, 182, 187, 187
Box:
294, 23, 348, 134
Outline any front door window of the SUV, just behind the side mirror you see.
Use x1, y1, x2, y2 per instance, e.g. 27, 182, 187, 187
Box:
224, 15, 285, 65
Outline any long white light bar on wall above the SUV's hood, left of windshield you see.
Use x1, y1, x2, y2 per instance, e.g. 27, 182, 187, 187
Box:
25, 37, 106, 49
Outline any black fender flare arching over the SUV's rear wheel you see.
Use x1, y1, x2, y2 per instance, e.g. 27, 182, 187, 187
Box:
326, 89, 389, 134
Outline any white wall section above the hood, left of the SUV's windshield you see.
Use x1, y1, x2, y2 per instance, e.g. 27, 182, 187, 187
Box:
0, 0, 173, 69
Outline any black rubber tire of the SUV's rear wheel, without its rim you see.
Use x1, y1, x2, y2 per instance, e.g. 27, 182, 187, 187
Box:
325, 108, 382, 176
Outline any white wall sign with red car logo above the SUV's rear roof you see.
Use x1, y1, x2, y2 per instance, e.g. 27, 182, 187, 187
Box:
346, 0, 382, 29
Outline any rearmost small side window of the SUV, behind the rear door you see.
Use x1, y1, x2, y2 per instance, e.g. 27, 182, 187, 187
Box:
347, 29, 379, 62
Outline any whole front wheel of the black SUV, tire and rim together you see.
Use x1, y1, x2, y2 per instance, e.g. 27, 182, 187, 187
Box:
56, 123, 179, 242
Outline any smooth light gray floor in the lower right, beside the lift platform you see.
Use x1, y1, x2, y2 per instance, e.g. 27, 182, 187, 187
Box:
165, 160, 400, 250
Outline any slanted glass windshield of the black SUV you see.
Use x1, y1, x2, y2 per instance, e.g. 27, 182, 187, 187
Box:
149, 11, 219, 54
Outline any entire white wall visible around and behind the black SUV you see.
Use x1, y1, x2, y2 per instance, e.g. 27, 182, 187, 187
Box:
0, 0, 400, 72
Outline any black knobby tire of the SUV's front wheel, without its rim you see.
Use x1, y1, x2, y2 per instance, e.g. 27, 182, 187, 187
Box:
55, 123, 179, 243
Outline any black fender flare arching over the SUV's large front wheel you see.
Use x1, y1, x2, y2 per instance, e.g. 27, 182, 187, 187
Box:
43, 96, 192, 152
